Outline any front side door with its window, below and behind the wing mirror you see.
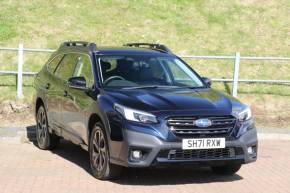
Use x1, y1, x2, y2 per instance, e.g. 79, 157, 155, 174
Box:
62, 54, 94, 144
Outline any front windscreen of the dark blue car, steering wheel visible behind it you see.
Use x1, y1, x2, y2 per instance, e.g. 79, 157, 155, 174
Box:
99, 55, 204, 88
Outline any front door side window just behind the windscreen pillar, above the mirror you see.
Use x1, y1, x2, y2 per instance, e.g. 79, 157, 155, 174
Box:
73, 55, 94, 87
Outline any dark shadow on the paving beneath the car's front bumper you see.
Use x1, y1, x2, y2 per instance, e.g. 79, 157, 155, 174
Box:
114, 167, 243, 186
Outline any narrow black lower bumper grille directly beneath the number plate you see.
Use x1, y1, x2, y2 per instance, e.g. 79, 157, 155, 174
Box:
167, 147, 235, 160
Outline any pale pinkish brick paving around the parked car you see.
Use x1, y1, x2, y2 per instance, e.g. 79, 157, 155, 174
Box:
0, 139, 290, 193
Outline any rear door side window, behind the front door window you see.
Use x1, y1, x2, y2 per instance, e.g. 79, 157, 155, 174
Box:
55, 54, 77, 80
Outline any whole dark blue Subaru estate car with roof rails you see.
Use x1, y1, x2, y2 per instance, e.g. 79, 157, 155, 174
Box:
34, 41, 258, 180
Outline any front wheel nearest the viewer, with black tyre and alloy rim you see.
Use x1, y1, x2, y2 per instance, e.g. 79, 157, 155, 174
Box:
89, 123, 122, 180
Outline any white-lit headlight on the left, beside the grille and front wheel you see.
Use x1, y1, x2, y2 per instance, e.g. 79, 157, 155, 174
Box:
114, 104, 157, 123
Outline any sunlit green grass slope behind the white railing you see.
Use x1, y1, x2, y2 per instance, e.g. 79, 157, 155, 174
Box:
0, 0, 290, 102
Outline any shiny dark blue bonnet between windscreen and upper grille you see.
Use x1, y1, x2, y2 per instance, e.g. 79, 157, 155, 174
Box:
106, 88, 239, 114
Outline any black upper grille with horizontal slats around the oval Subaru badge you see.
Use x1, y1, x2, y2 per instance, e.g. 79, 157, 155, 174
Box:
167, 116, 236, 137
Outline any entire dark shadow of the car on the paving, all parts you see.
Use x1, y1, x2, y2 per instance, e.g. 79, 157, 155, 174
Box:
27, 126, 243, 186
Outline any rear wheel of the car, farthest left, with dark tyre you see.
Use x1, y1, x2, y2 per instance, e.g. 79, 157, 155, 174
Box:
36, 106, 60, 150
